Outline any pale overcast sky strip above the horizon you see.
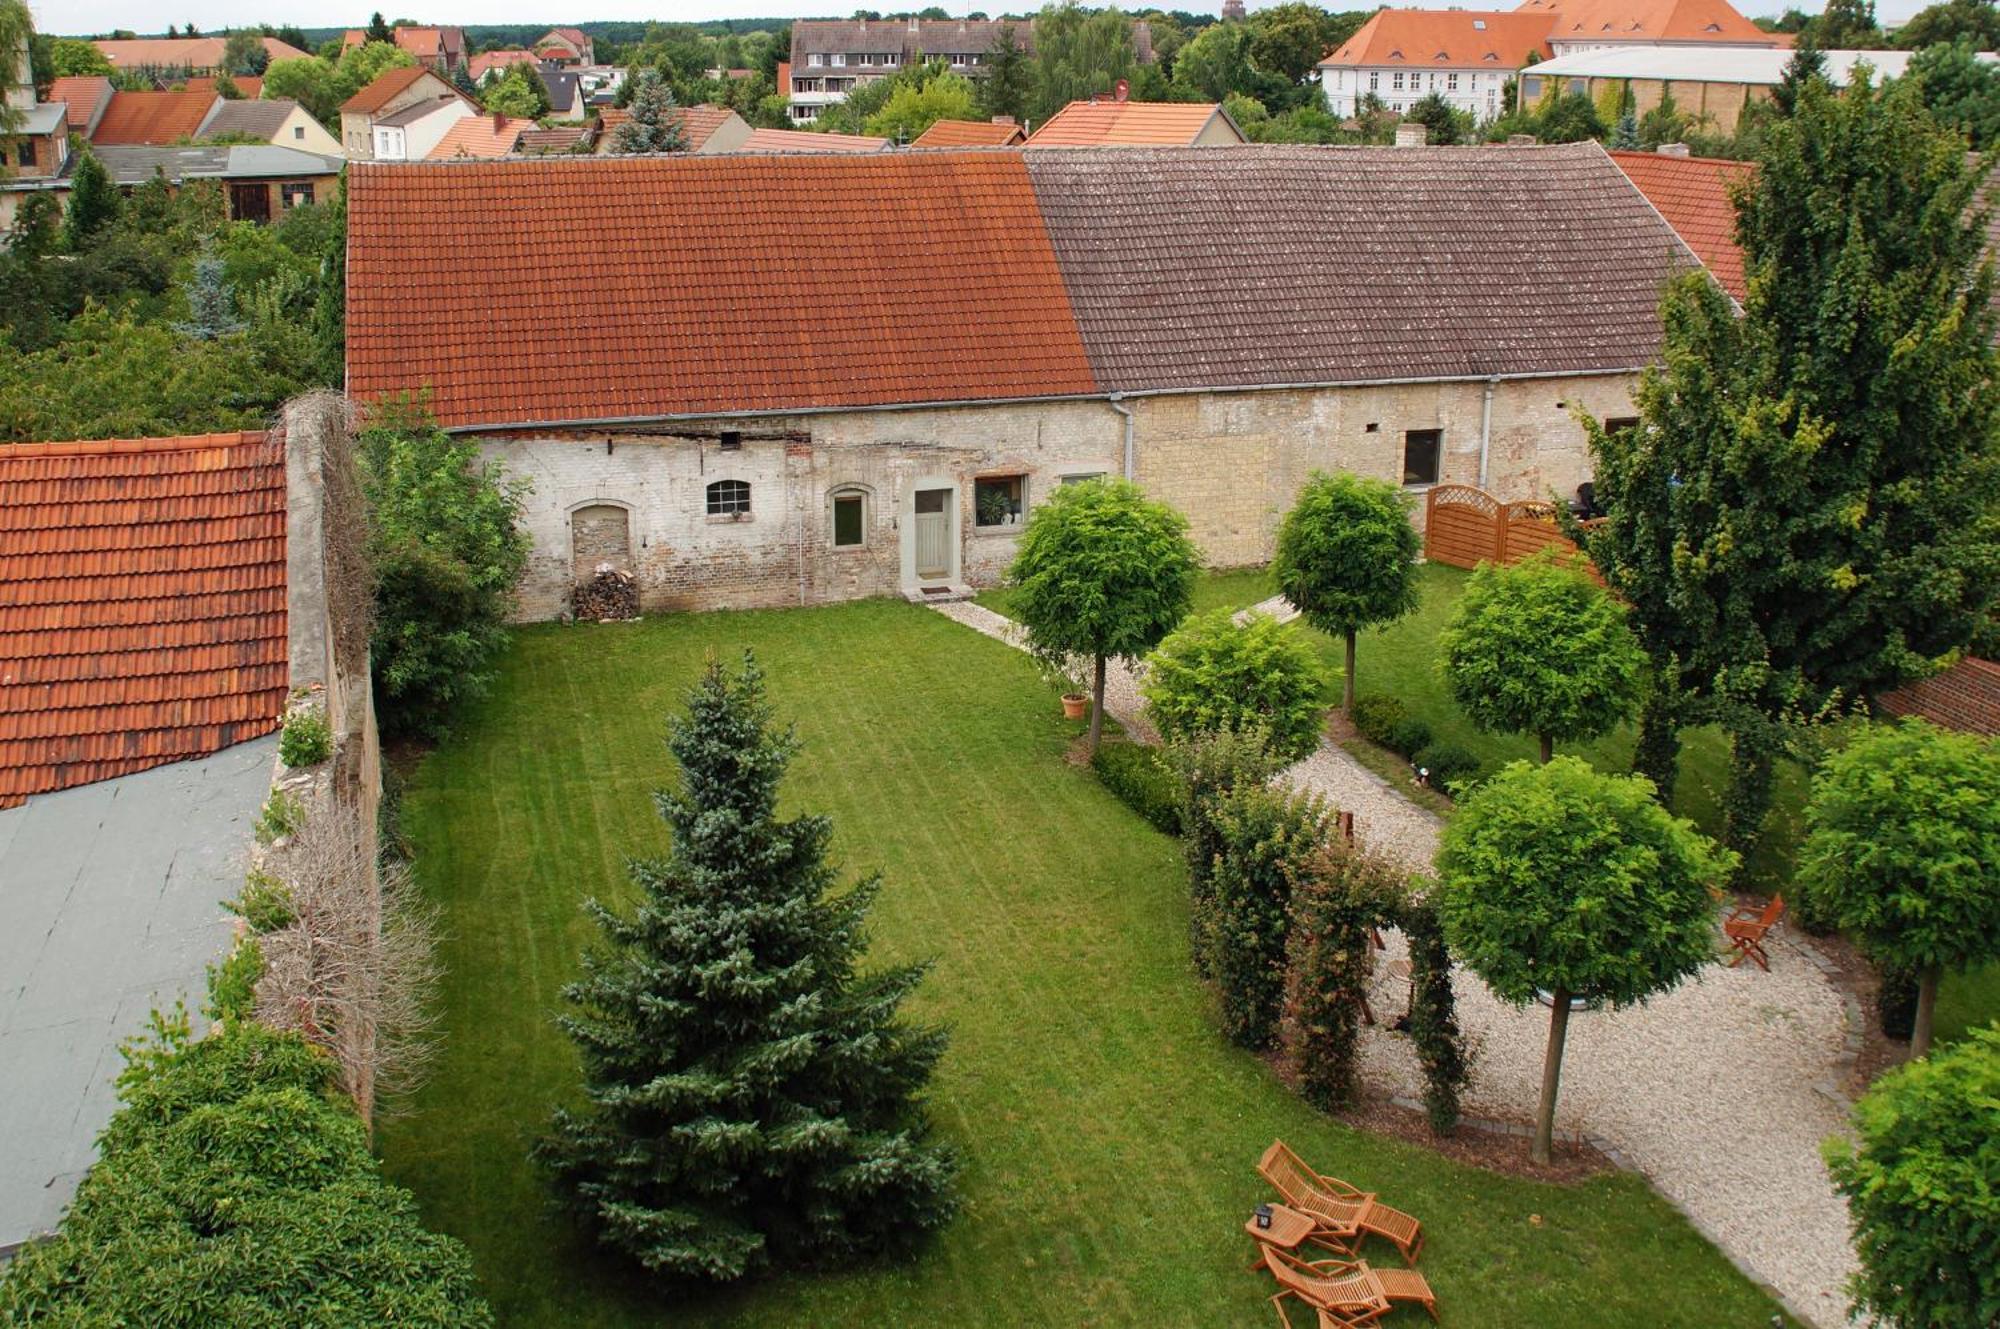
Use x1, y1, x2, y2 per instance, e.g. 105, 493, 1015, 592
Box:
28, 0, 1924, 43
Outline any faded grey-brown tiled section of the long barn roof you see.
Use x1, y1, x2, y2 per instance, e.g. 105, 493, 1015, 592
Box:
1024, 142, 1692, 390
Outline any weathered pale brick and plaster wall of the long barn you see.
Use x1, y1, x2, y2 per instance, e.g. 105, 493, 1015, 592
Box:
482, 374, 1636, 618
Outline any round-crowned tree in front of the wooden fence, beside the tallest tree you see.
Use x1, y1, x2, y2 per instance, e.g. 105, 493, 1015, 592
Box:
1438, 554, 1646, 763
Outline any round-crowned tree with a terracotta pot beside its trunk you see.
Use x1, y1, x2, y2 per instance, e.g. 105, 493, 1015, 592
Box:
1008, 480, 1200, 757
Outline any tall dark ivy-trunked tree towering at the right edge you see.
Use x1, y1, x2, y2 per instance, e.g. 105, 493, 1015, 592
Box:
1588, 78, 2000, 857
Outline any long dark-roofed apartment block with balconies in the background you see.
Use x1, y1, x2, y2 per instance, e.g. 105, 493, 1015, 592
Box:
778, 18, 1154, 120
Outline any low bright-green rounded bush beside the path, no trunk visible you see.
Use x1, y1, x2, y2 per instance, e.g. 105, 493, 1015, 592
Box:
1140, 608, 1326, 761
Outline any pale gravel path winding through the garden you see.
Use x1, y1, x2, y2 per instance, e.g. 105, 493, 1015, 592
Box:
932, 596, 1854, 1329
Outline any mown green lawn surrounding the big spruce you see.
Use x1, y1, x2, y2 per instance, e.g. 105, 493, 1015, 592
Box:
382, 600, 1774, 1329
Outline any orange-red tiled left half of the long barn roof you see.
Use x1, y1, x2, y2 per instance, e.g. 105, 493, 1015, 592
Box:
348, 152, 1096, 424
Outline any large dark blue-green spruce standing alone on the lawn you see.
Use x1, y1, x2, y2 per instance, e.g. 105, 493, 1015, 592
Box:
536, 652, 956, 1281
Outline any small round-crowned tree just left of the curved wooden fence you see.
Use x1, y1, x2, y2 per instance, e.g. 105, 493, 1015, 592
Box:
1272, 470, 1422, 717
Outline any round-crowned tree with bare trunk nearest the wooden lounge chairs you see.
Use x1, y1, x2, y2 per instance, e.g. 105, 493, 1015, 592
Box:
1436, 757, 1736, 1163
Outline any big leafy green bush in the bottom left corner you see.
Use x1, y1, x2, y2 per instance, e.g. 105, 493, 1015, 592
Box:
0, 1013, 492, 1329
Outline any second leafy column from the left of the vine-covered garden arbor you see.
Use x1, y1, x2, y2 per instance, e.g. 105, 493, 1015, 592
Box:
1212, 785, 1332, 1049
